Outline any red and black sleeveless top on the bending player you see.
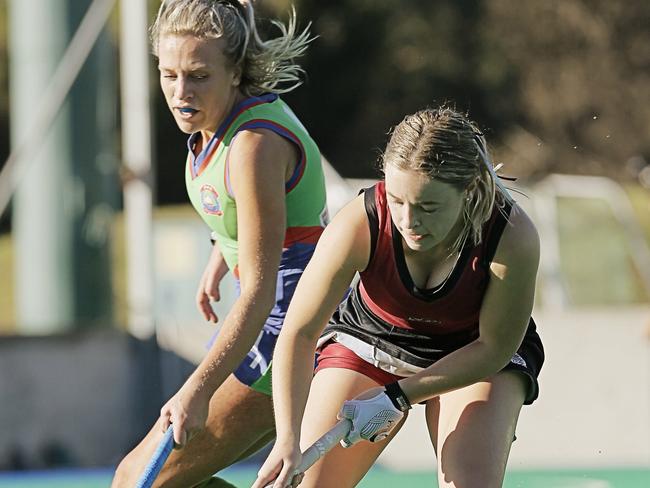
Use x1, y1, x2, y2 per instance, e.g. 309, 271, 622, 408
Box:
323, 182, 512, 367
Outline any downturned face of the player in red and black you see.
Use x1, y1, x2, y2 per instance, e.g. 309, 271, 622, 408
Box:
385, 164, 465, 251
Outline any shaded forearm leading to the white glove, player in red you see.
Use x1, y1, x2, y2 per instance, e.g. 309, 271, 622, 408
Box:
399, 340, 509, 404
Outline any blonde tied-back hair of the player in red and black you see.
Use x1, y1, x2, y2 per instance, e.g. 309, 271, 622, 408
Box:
381, 106, 511, 252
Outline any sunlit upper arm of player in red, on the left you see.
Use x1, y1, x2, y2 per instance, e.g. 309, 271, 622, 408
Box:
282, 195, 370, 340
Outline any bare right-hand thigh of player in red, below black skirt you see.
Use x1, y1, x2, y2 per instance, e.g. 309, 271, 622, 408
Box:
426, 371, 528, 488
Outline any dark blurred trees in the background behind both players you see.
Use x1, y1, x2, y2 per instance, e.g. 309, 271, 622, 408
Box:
5, 0, 650, 212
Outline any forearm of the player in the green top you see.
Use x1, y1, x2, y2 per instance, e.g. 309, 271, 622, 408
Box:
187, 294, 273, 396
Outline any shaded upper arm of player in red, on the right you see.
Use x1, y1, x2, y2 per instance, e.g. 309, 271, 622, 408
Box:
479, 205, 539, 364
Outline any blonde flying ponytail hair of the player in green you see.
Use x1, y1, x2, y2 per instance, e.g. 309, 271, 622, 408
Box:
150, 0, 313, 96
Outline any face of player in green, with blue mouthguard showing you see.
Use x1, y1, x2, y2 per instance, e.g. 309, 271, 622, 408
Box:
158, 35, 241, 137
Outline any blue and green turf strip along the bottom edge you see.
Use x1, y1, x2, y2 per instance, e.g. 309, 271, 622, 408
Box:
0, 468, 650, 488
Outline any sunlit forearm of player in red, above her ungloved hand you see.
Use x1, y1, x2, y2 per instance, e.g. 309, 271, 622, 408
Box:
272, 330, 316, 443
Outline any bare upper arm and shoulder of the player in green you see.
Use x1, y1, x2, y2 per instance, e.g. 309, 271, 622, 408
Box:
229, 129, 295, 300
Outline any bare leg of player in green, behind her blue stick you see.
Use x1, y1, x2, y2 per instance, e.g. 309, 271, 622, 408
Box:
112, 375, 274, 488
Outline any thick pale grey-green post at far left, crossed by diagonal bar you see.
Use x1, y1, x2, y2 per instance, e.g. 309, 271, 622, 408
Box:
9, 0, 73, 334
